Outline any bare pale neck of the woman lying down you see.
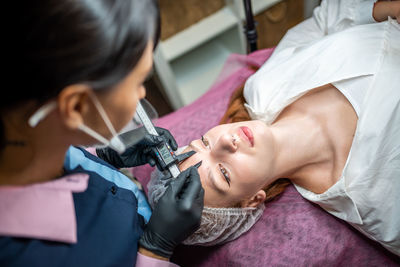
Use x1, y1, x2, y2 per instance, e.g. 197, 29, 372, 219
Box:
271, 116, 333, 186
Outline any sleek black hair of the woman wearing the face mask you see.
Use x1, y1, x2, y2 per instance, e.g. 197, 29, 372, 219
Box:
0, 0, 160, 151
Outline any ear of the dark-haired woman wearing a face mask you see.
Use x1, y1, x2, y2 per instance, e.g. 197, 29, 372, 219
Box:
57, 84, 91, 129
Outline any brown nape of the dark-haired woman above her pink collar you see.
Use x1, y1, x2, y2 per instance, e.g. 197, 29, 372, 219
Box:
0, 108, 69, 185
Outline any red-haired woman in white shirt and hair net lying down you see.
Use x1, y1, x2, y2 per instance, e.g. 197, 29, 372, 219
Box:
149, 1, 400, 255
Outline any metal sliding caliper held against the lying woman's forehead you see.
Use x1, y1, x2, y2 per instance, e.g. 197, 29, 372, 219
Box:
136, 101, 181, 178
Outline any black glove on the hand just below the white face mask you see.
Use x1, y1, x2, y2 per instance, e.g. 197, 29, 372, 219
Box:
96, 127, 178, 169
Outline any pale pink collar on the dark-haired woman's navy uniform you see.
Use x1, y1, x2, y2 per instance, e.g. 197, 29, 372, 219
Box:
0, 173, 89, 244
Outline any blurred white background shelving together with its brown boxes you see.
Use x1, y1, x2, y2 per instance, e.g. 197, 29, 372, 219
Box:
145, 0, 320, 117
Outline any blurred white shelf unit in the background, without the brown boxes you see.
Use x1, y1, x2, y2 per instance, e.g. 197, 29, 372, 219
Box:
154, 0, 280, 109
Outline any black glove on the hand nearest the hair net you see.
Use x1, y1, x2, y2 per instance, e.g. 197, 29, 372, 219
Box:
139, 167, 204, 258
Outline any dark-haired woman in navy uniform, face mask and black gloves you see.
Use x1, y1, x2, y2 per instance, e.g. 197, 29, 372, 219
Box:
0, 0, 204, 266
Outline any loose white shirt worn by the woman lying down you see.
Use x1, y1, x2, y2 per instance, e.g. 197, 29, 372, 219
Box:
244, 0, 400, 255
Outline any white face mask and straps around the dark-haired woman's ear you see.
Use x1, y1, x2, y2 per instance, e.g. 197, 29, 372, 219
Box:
28, 94, 126, 154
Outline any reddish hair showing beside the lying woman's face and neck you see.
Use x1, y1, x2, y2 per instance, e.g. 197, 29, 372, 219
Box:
219, 86, 290, 202
